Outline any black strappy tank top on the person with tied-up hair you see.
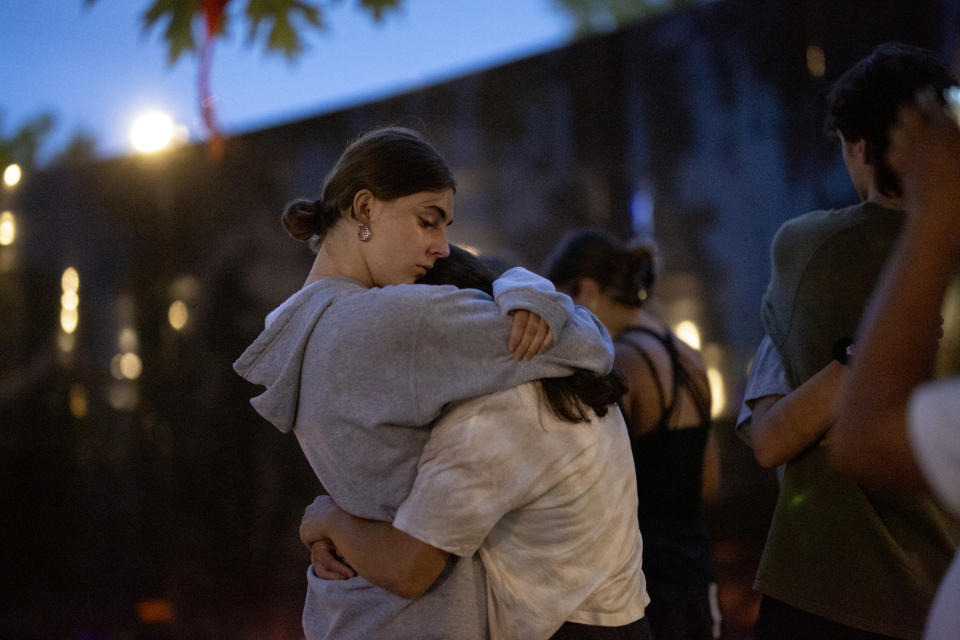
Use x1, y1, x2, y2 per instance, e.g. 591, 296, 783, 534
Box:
615, 327, 713, 585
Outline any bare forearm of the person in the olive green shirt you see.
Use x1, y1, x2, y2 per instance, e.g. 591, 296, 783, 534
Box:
750, 362, 844, 467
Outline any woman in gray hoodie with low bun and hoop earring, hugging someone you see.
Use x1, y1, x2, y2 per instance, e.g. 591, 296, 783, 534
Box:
234, 127, 613, 640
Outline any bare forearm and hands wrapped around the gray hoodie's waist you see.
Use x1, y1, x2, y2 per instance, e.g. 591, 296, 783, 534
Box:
300, 496, 448, 598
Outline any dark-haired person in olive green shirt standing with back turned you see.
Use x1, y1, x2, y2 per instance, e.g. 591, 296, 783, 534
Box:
743, 44, 960, 640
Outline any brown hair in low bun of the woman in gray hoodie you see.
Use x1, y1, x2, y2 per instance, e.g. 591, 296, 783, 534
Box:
282, 127, 456, 244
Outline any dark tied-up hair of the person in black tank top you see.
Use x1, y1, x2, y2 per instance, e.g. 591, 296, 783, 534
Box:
544, 229, 656, 307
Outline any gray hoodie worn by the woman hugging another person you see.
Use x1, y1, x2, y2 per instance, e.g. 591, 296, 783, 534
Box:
234, 269, 613, 640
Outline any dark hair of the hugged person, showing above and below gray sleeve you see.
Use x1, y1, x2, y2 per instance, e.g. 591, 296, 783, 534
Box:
417, 245, 627, 422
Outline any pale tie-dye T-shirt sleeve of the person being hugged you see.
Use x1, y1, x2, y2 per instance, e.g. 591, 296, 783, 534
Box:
393, 390, 540, 557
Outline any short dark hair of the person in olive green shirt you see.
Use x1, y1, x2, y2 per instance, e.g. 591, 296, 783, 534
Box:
824, 42, 956, 196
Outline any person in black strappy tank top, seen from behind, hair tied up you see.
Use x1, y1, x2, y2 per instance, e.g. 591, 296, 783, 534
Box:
544, 230, 720, 640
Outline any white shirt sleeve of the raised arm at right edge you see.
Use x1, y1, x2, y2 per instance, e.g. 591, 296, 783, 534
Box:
907, 377, 960, 516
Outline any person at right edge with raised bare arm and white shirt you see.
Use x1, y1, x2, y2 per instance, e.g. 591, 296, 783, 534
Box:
831, 93, 960, 640
